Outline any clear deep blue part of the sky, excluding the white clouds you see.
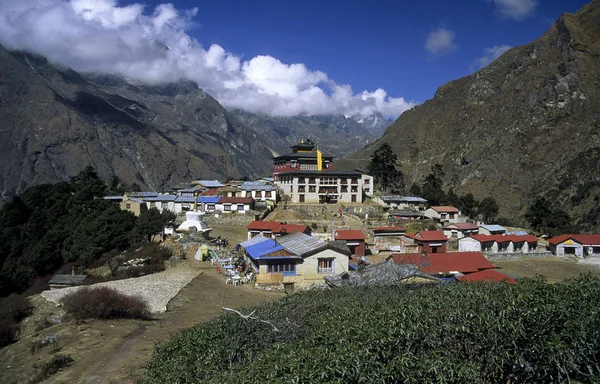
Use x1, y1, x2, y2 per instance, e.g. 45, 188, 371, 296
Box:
157, 0, 587, 102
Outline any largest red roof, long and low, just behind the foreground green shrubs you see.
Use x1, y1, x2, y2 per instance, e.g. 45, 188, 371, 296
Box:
387, 252, 496, 276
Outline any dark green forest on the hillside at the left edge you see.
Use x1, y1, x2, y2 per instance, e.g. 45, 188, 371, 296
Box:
0, 167, 174, 296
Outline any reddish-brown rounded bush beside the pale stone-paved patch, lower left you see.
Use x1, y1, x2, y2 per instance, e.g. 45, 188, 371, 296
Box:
62, 287, 150, 320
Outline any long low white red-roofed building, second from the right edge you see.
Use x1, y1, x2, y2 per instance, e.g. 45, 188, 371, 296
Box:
458, 235, 538, 253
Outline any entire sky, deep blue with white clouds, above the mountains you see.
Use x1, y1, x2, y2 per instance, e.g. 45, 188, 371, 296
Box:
0, 0, 586, 118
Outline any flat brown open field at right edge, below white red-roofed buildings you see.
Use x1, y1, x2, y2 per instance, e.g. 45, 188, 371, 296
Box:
492, 257, 600, 283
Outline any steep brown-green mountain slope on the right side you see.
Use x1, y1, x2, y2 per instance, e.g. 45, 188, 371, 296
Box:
344, 0, 600, 222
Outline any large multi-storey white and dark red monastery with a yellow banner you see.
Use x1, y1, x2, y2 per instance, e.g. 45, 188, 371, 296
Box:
273, 141, 373, 204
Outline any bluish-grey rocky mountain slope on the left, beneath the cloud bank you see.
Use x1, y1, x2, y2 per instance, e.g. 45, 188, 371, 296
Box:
0, 47, 271, 202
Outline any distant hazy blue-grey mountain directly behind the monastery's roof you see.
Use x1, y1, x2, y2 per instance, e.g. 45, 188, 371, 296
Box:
231, 110, 391, 158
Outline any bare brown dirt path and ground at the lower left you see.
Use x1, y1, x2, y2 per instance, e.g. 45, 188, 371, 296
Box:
0, 259, 282, 384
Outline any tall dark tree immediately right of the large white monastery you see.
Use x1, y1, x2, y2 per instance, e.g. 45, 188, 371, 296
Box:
368, 143, 404, 192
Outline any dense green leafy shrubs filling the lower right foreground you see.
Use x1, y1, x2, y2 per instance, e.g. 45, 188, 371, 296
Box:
146, 275, 600, 383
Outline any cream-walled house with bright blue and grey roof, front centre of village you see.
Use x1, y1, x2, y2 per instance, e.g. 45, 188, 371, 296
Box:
240, 232, 350, 292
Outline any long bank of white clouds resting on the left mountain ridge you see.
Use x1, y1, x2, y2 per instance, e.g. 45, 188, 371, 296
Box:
0, 0, 415, 117
